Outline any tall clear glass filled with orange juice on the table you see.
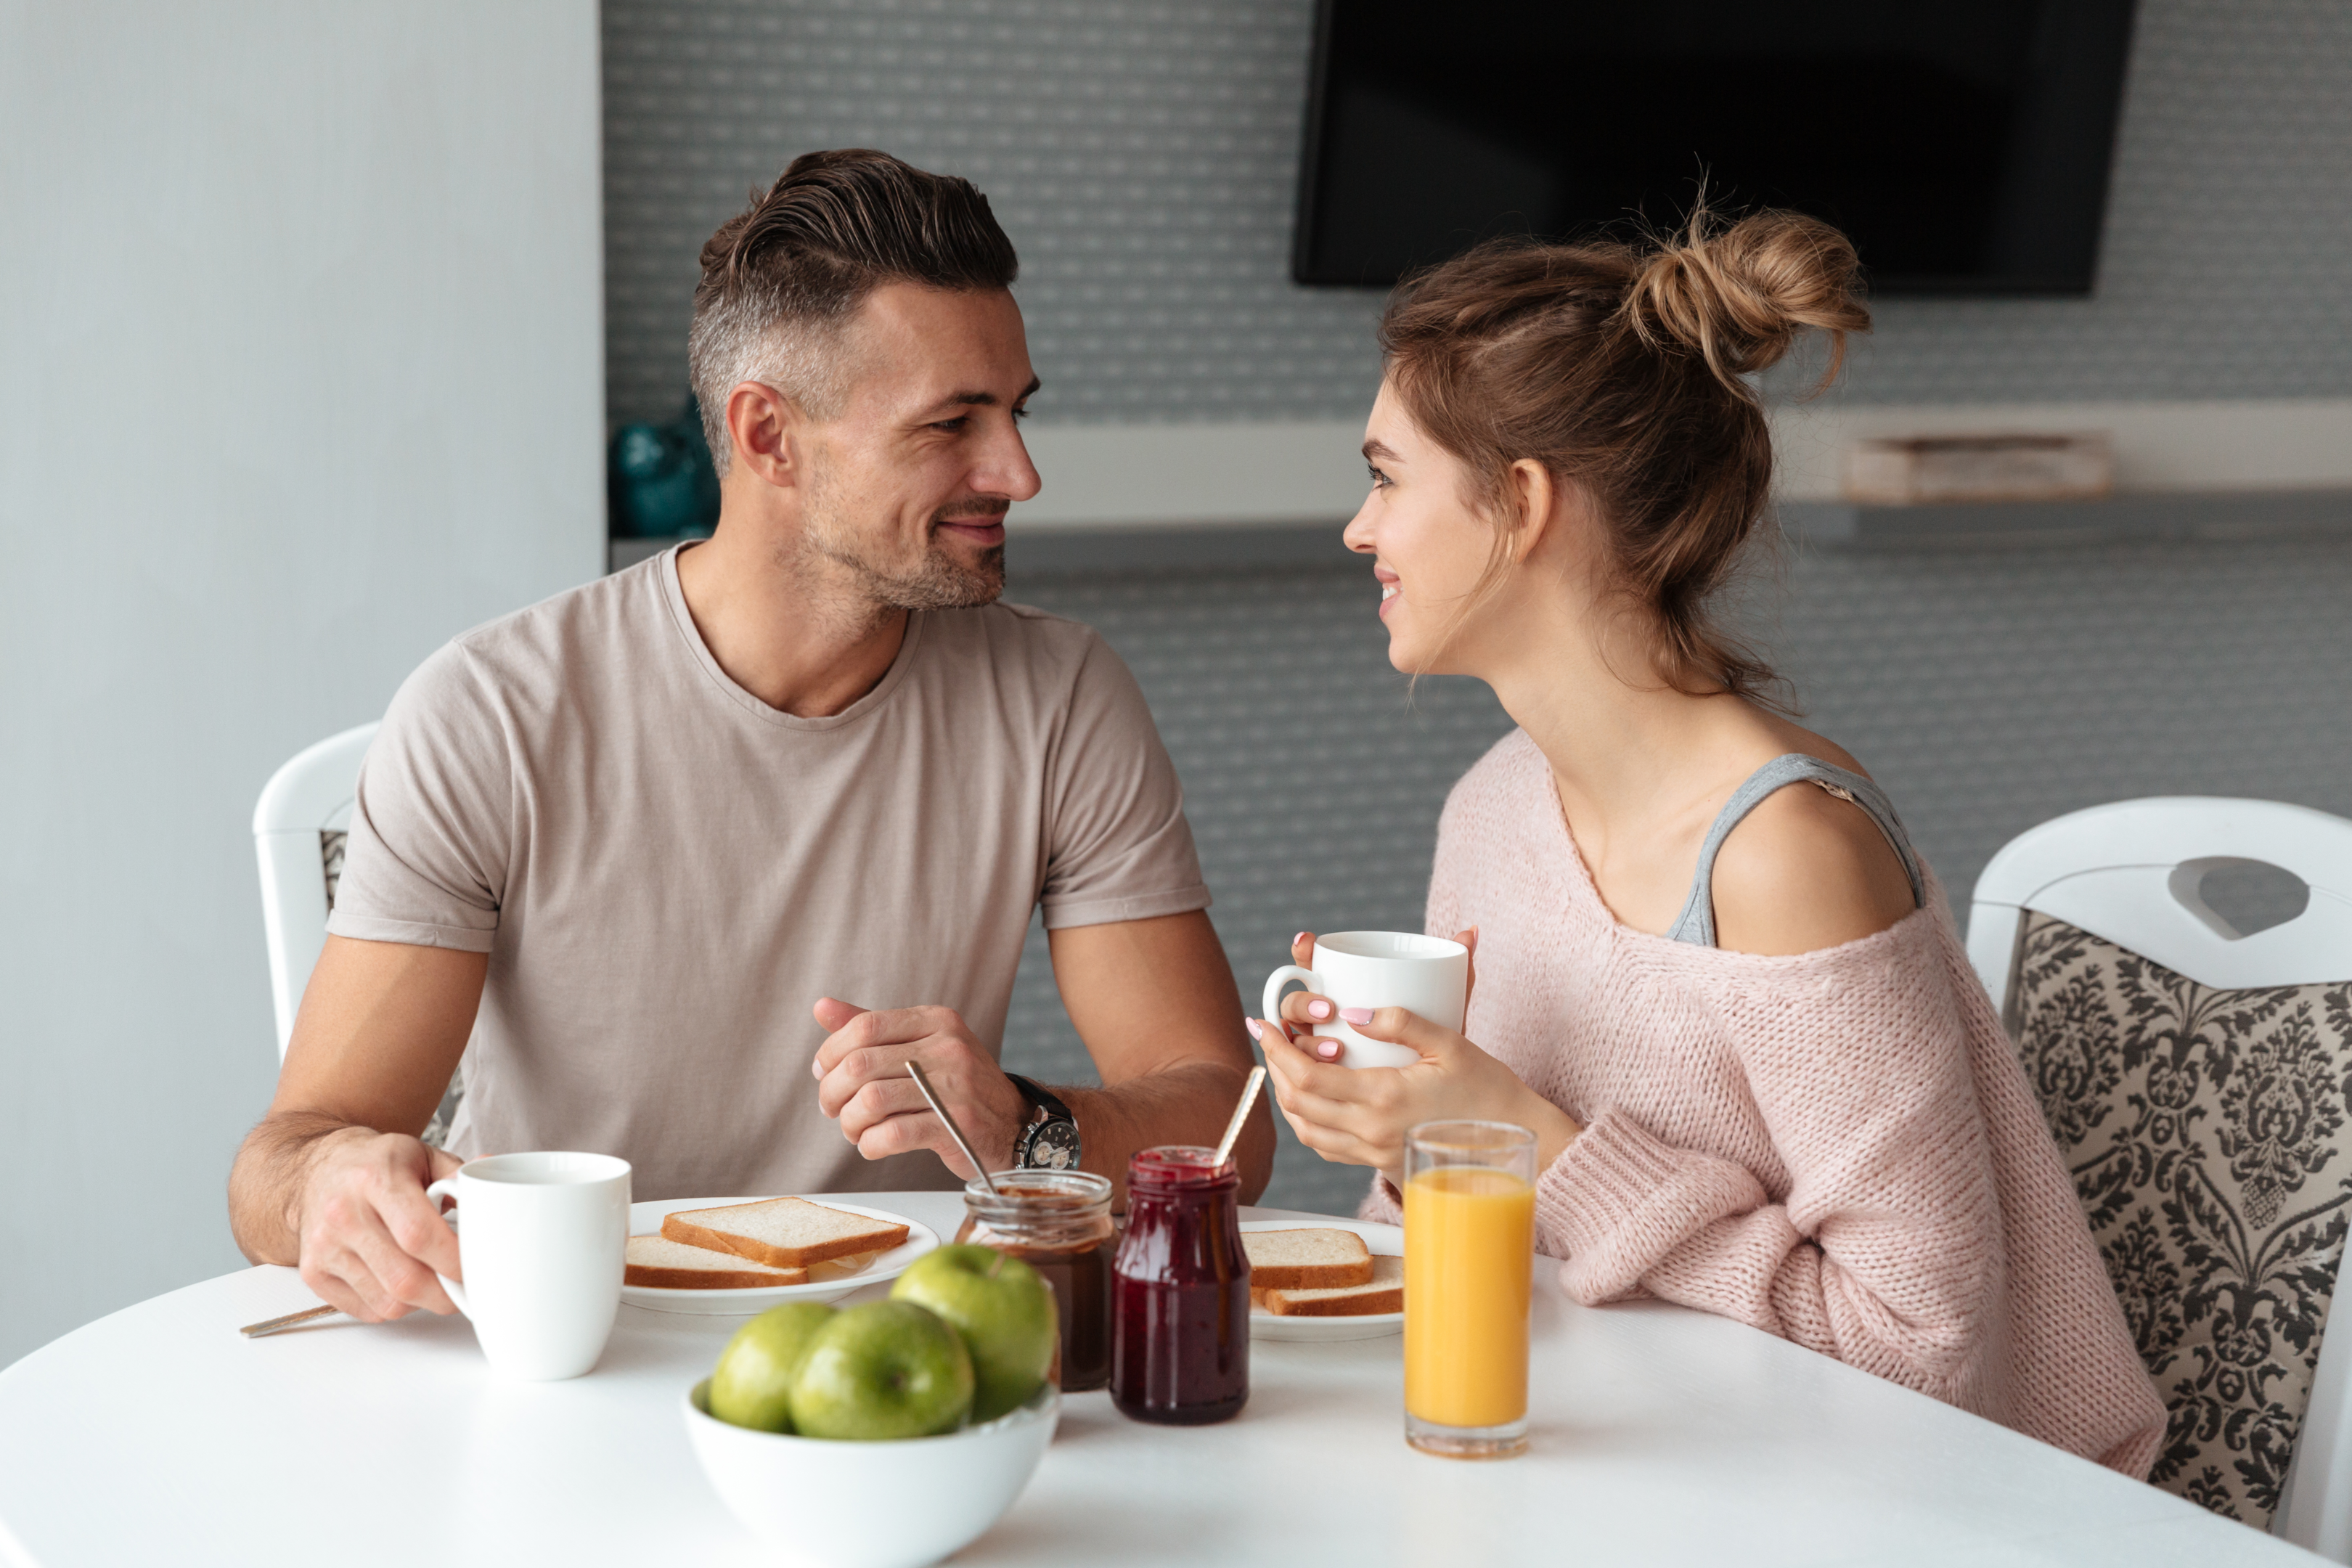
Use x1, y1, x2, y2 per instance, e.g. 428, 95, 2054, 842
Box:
1404, 1122, 1536, 1460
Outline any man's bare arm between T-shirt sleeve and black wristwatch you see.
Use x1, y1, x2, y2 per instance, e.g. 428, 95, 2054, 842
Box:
1047, 910, 1275, 1204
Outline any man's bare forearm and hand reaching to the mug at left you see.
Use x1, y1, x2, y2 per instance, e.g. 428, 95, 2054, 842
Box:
228, 936, 489, 1319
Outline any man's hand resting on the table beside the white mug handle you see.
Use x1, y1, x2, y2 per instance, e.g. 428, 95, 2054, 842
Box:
292, 1126, 463, 1323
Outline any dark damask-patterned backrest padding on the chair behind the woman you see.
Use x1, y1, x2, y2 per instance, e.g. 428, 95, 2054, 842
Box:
2009, 912, 2352, 1528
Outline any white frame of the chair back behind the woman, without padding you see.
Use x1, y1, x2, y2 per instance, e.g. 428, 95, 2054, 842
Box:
1969, 795, 2352, 1564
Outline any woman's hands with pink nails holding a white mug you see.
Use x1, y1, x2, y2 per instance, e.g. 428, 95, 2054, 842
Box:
1249, 931, 1583, 1187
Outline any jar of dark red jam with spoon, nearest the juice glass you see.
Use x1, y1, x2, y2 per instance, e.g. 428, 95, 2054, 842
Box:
1110, 1145, 1249, 1427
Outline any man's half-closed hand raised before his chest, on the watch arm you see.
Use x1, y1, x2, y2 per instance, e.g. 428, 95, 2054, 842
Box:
809, 997, 1030, 1183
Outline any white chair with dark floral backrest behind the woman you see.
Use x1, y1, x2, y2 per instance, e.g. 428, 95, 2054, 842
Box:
1969, 797, 2352, 1564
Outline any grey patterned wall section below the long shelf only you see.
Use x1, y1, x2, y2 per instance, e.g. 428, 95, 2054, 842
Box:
1004, 526, 2352, 1211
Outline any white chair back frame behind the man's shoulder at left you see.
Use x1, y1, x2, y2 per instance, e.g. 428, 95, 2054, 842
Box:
254, 724, 376, 1061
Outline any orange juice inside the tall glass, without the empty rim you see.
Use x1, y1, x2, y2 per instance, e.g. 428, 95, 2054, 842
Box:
1404, 1166, 1536, 1427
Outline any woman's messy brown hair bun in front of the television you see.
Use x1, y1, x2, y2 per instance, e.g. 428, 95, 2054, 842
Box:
1623, 203, 1870, 397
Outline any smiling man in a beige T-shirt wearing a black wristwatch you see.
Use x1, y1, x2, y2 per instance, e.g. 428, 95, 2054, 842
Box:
231, 150, 1273, 1319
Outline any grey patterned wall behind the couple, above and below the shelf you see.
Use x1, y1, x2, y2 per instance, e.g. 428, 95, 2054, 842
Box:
605, 0, 2352, 1209
